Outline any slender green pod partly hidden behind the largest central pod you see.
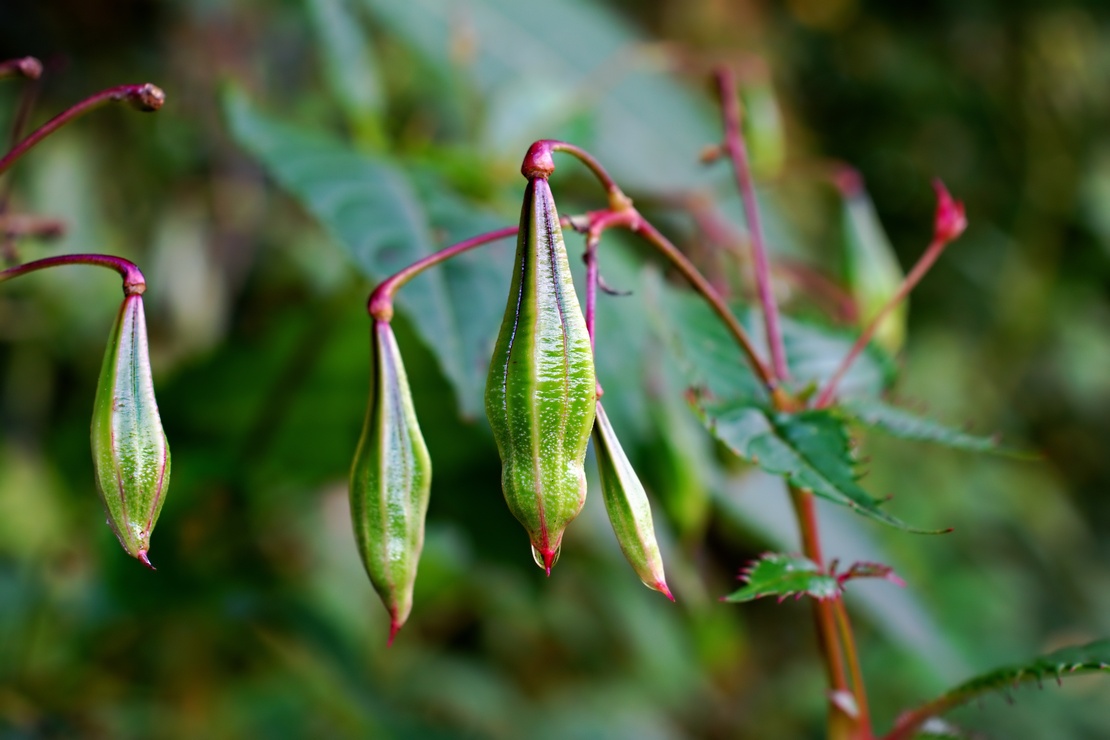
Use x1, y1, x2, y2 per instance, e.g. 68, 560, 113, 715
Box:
594, 404, 675, 601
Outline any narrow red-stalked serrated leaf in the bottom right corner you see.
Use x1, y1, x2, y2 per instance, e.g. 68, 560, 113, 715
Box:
887, 639, 1110, 740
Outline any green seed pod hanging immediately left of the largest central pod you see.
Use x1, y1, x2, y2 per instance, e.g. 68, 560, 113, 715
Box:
351, 321, 432, 643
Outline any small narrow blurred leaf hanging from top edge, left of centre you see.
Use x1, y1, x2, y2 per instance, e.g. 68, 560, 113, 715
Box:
309, 0, 384, 144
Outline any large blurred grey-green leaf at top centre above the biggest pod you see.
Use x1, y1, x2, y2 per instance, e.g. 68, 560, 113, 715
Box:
364, 0, 719, 192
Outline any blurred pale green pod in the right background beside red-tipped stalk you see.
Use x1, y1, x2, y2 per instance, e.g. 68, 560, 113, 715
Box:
841, 173, 908, 354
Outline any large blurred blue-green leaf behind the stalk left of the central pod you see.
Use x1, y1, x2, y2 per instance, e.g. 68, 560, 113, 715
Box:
224, 91, 512, 416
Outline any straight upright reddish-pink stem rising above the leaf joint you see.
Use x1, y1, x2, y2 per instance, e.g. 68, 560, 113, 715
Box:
717, 68, 789, 381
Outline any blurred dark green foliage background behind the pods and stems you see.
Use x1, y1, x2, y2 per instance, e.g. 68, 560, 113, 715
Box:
0, 0, 1110, 738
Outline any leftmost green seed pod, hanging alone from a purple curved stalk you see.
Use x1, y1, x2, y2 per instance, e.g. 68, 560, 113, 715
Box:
92, 293, 170, 568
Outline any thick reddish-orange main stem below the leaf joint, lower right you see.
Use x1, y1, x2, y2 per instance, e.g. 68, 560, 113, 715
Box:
790, 486, 871, 740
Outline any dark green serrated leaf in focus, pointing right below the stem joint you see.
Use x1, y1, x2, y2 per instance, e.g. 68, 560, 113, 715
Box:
698, 402, 936, 534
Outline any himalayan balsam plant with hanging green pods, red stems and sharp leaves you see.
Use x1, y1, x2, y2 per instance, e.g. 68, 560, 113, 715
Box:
0, 49, 1110, 740
